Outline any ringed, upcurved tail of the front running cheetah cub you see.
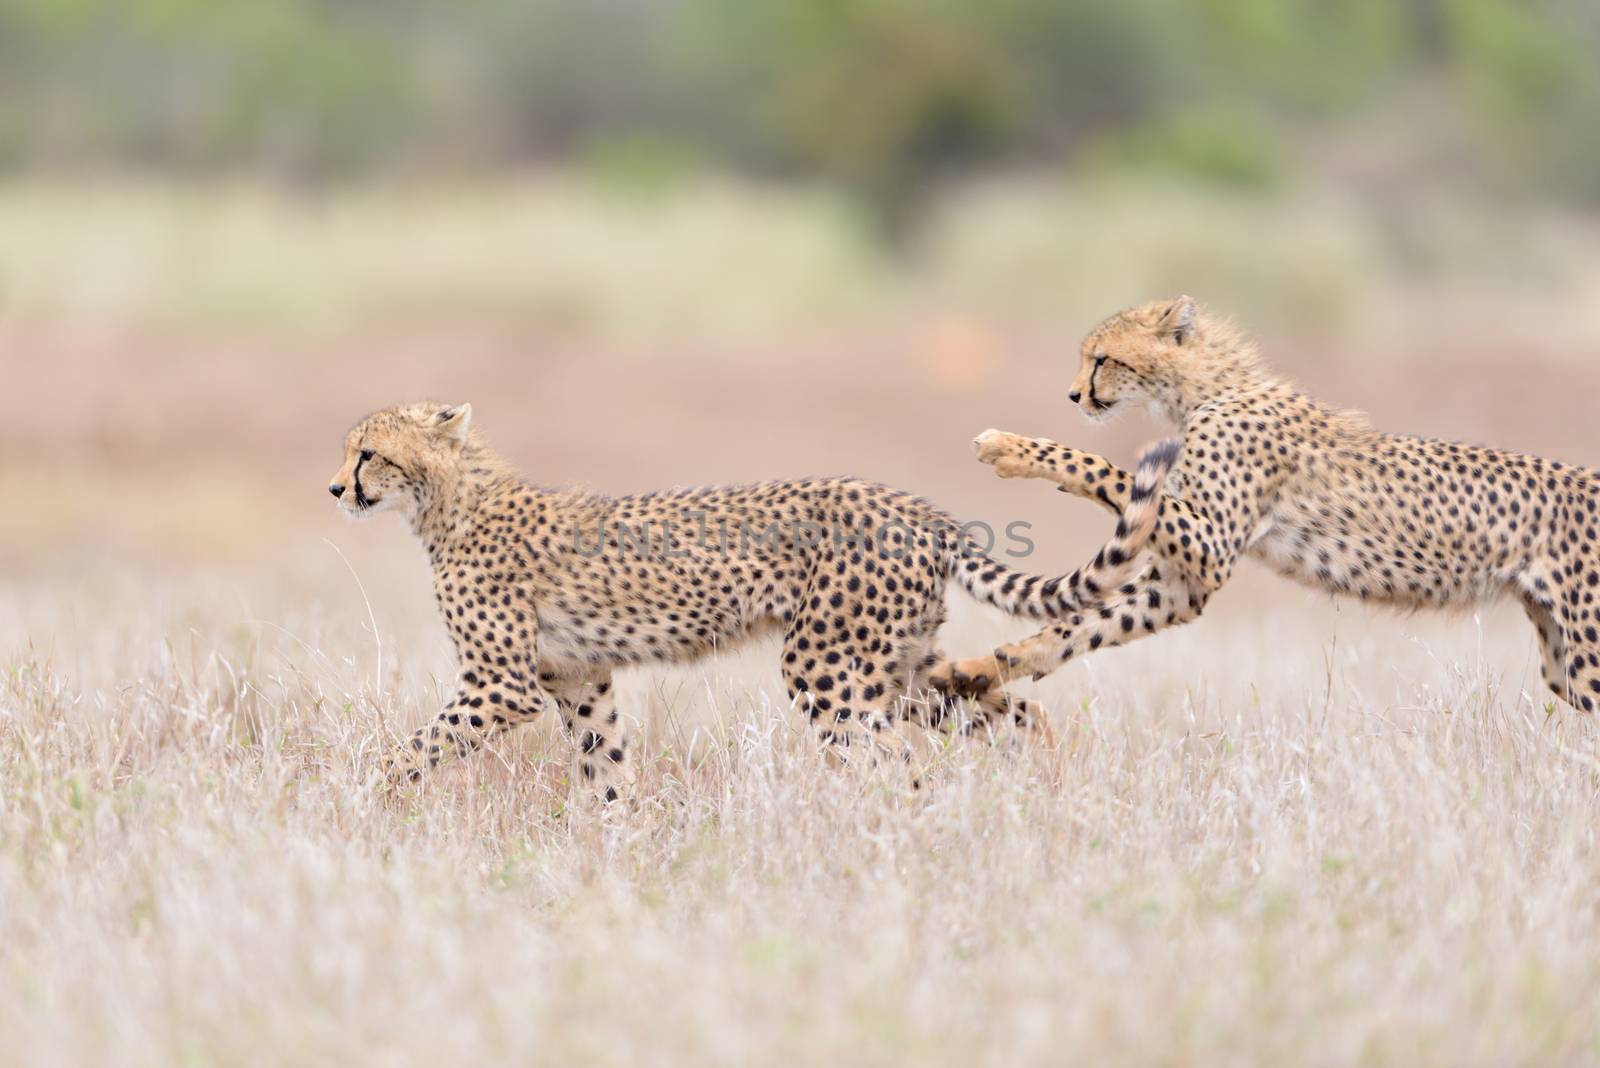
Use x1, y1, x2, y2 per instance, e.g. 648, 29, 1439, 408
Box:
950, 440, 1182, 619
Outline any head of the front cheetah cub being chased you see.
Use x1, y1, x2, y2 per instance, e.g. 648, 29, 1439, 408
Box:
328, 403, 472, 516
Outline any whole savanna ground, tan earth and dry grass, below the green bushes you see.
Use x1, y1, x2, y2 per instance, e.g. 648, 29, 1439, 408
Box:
0, 179, 1600, 1065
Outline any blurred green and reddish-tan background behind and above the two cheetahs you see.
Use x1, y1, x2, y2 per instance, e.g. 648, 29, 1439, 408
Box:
0, 0, 1600, 671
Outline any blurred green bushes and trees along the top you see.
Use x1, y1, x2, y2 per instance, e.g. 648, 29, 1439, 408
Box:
0, 0, 1600, 225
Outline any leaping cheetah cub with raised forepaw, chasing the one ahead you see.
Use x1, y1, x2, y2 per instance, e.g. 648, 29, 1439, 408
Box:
933, 297, 1600, 711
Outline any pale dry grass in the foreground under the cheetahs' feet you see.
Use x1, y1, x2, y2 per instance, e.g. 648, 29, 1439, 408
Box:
0, 549, 1600, 1065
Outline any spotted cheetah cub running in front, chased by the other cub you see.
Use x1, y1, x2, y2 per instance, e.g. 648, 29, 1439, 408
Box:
328, 403, 1154, 799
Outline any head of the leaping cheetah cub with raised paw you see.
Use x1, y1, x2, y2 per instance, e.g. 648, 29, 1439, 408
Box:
1067, 297, 1200, 422
